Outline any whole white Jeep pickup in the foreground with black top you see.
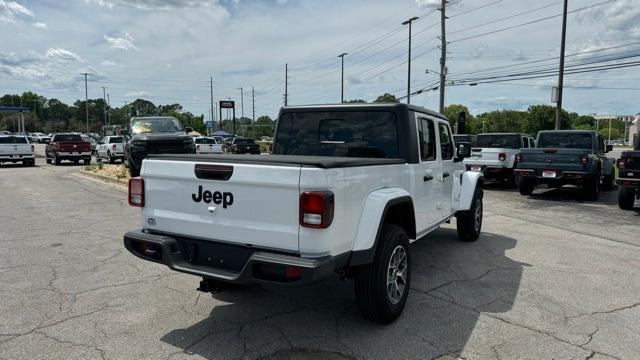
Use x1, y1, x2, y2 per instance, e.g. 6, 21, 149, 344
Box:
124, 104, 483, 323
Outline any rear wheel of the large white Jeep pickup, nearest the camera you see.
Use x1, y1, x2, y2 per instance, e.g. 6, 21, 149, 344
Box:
355, 224, 411, 324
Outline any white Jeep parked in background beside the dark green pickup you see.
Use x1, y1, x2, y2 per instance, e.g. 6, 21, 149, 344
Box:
464, 133, 535, 184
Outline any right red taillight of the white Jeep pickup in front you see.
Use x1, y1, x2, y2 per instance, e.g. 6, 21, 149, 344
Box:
300, 191, 334, 229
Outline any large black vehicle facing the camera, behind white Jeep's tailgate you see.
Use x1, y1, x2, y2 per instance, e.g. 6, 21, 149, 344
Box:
124, 116, 196, 177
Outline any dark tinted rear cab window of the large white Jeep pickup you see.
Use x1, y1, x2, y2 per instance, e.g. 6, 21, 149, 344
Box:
273, 111, 399, 158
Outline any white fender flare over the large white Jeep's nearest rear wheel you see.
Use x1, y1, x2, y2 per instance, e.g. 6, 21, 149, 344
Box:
349, 188, 415, 266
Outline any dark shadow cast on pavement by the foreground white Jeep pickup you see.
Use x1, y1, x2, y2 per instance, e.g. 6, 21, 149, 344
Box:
161, 228, 529, 359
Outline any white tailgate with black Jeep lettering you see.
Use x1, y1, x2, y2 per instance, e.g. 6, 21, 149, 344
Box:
141, 159, 300, 252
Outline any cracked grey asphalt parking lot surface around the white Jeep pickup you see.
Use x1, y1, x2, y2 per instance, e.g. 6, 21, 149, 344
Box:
0, 158, 640, 359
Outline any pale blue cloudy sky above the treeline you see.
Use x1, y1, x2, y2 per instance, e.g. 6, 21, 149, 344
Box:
0, 0, 640, 121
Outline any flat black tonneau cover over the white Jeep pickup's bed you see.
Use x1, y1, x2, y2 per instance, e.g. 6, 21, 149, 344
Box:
147, 154, 406, 169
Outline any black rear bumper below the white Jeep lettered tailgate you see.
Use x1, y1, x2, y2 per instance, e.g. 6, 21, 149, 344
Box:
124, 230, 340, 286
